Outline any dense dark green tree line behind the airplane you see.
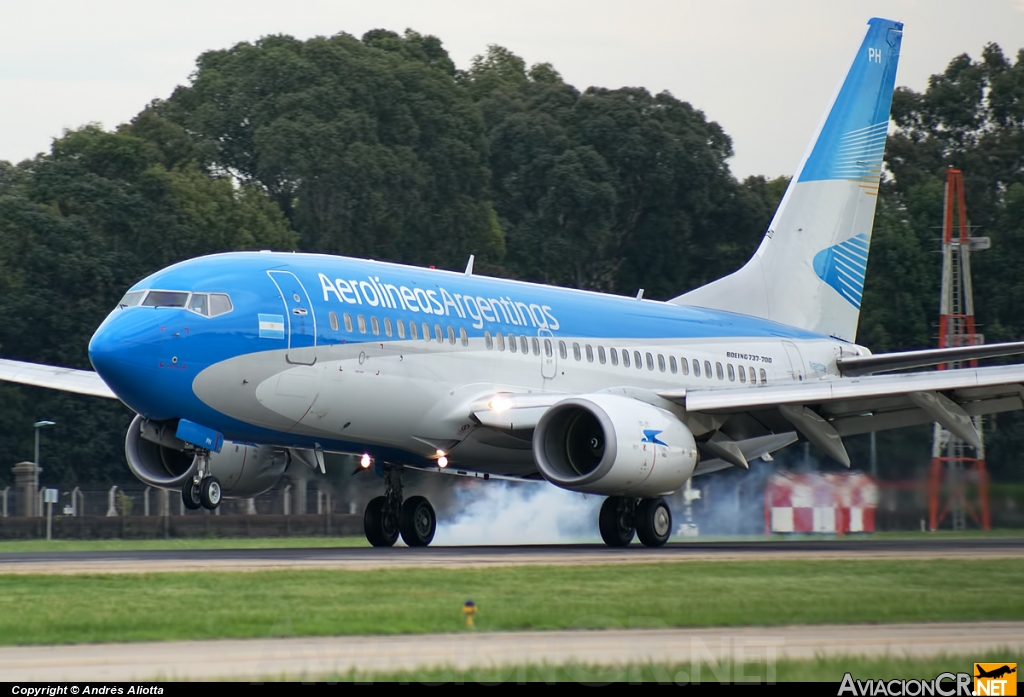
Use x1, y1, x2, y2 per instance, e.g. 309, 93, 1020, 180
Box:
0, 30, 1024, 484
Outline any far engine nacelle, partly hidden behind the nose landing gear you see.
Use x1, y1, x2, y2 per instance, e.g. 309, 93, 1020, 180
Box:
125, 416, 291, 498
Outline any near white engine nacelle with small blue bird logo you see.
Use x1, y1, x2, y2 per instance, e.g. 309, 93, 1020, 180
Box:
534, 394, 697, 497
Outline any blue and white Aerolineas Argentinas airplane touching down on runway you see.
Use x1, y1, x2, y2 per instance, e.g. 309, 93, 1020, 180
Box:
0, 18, 1024, 547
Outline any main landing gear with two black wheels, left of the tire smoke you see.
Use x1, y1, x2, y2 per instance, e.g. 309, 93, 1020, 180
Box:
362, 465, 437, 547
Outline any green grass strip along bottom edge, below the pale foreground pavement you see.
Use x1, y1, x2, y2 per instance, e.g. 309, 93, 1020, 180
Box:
299, 650, 1024, 685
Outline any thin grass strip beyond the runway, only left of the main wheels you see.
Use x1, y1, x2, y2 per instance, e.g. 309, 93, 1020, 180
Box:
0, 535, 370, 554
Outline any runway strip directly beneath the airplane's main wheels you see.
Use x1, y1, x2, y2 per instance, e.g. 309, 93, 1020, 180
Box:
0, 534, 1024, 573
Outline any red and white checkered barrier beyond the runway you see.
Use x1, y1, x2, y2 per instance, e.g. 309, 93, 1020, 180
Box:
765, 472, 879, 535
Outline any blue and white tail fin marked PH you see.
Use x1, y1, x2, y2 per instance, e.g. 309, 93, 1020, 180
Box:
671, 17, 903, 341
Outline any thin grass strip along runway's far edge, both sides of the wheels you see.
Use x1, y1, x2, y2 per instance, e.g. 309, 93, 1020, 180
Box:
0, 528, 1024, 554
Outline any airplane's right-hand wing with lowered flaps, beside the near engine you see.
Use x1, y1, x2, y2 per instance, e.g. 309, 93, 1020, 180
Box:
658, 364, 1024, 464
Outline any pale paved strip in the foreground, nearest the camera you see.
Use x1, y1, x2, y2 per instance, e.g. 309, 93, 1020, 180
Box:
0, 622, 1024, 683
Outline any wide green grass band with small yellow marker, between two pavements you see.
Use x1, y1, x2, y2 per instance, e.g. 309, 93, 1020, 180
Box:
0, 559, 1024, 645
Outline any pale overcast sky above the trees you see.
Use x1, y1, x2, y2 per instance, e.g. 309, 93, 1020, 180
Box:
0, 0, 1024, 177
